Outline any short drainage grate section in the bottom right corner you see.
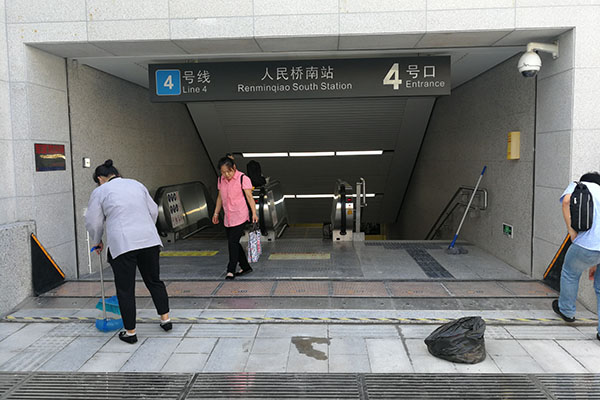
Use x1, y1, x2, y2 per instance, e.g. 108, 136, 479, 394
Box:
536, 374, 600, 400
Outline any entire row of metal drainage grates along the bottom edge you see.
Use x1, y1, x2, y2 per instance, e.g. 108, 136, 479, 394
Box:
0, 372, 600, 400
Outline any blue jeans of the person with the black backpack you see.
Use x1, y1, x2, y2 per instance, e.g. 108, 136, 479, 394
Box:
558, 244, 600, 332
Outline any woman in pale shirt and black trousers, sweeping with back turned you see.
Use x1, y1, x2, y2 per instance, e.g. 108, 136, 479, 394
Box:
85, 160, 173, 344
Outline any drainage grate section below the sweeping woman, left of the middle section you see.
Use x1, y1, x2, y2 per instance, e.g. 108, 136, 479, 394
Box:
6, 373, 192, 400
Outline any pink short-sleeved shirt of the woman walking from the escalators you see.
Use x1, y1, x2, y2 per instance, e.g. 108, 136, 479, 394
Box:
217, 171, 252, 227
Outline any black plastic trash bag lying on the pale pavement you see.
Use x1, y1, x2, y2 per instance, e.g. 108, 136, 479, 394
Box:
425, 317, 485, 364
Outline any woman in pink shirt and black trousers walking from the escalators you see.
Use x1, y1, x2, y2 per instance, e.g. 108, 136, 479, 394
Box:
213, 157, 258, 279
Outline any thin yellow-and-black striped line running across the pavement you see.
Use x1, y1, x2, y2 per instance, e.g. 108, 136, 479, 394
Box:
0, 315, 598, 326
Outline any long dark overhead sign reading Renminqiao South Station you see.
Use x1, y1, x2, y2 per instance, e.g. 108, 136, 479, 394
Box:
149, 56, 451, 102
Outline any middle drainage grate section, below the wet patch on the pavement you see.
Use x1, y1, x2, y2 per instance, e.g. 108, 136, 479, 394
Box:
186, 373, 360, 400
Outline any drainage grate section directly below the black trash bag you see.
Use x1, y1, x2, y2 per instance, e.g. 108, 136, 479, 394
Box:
365, 374, 548, 400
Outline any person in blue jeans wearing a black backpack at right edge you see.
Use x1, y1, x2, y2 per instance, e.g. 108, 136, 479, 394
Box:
552, 172, 600, 340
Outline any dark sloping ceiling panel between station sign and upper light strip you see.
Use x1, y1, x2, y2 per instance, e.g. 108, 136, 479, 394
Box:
215, 98, 406, 152
